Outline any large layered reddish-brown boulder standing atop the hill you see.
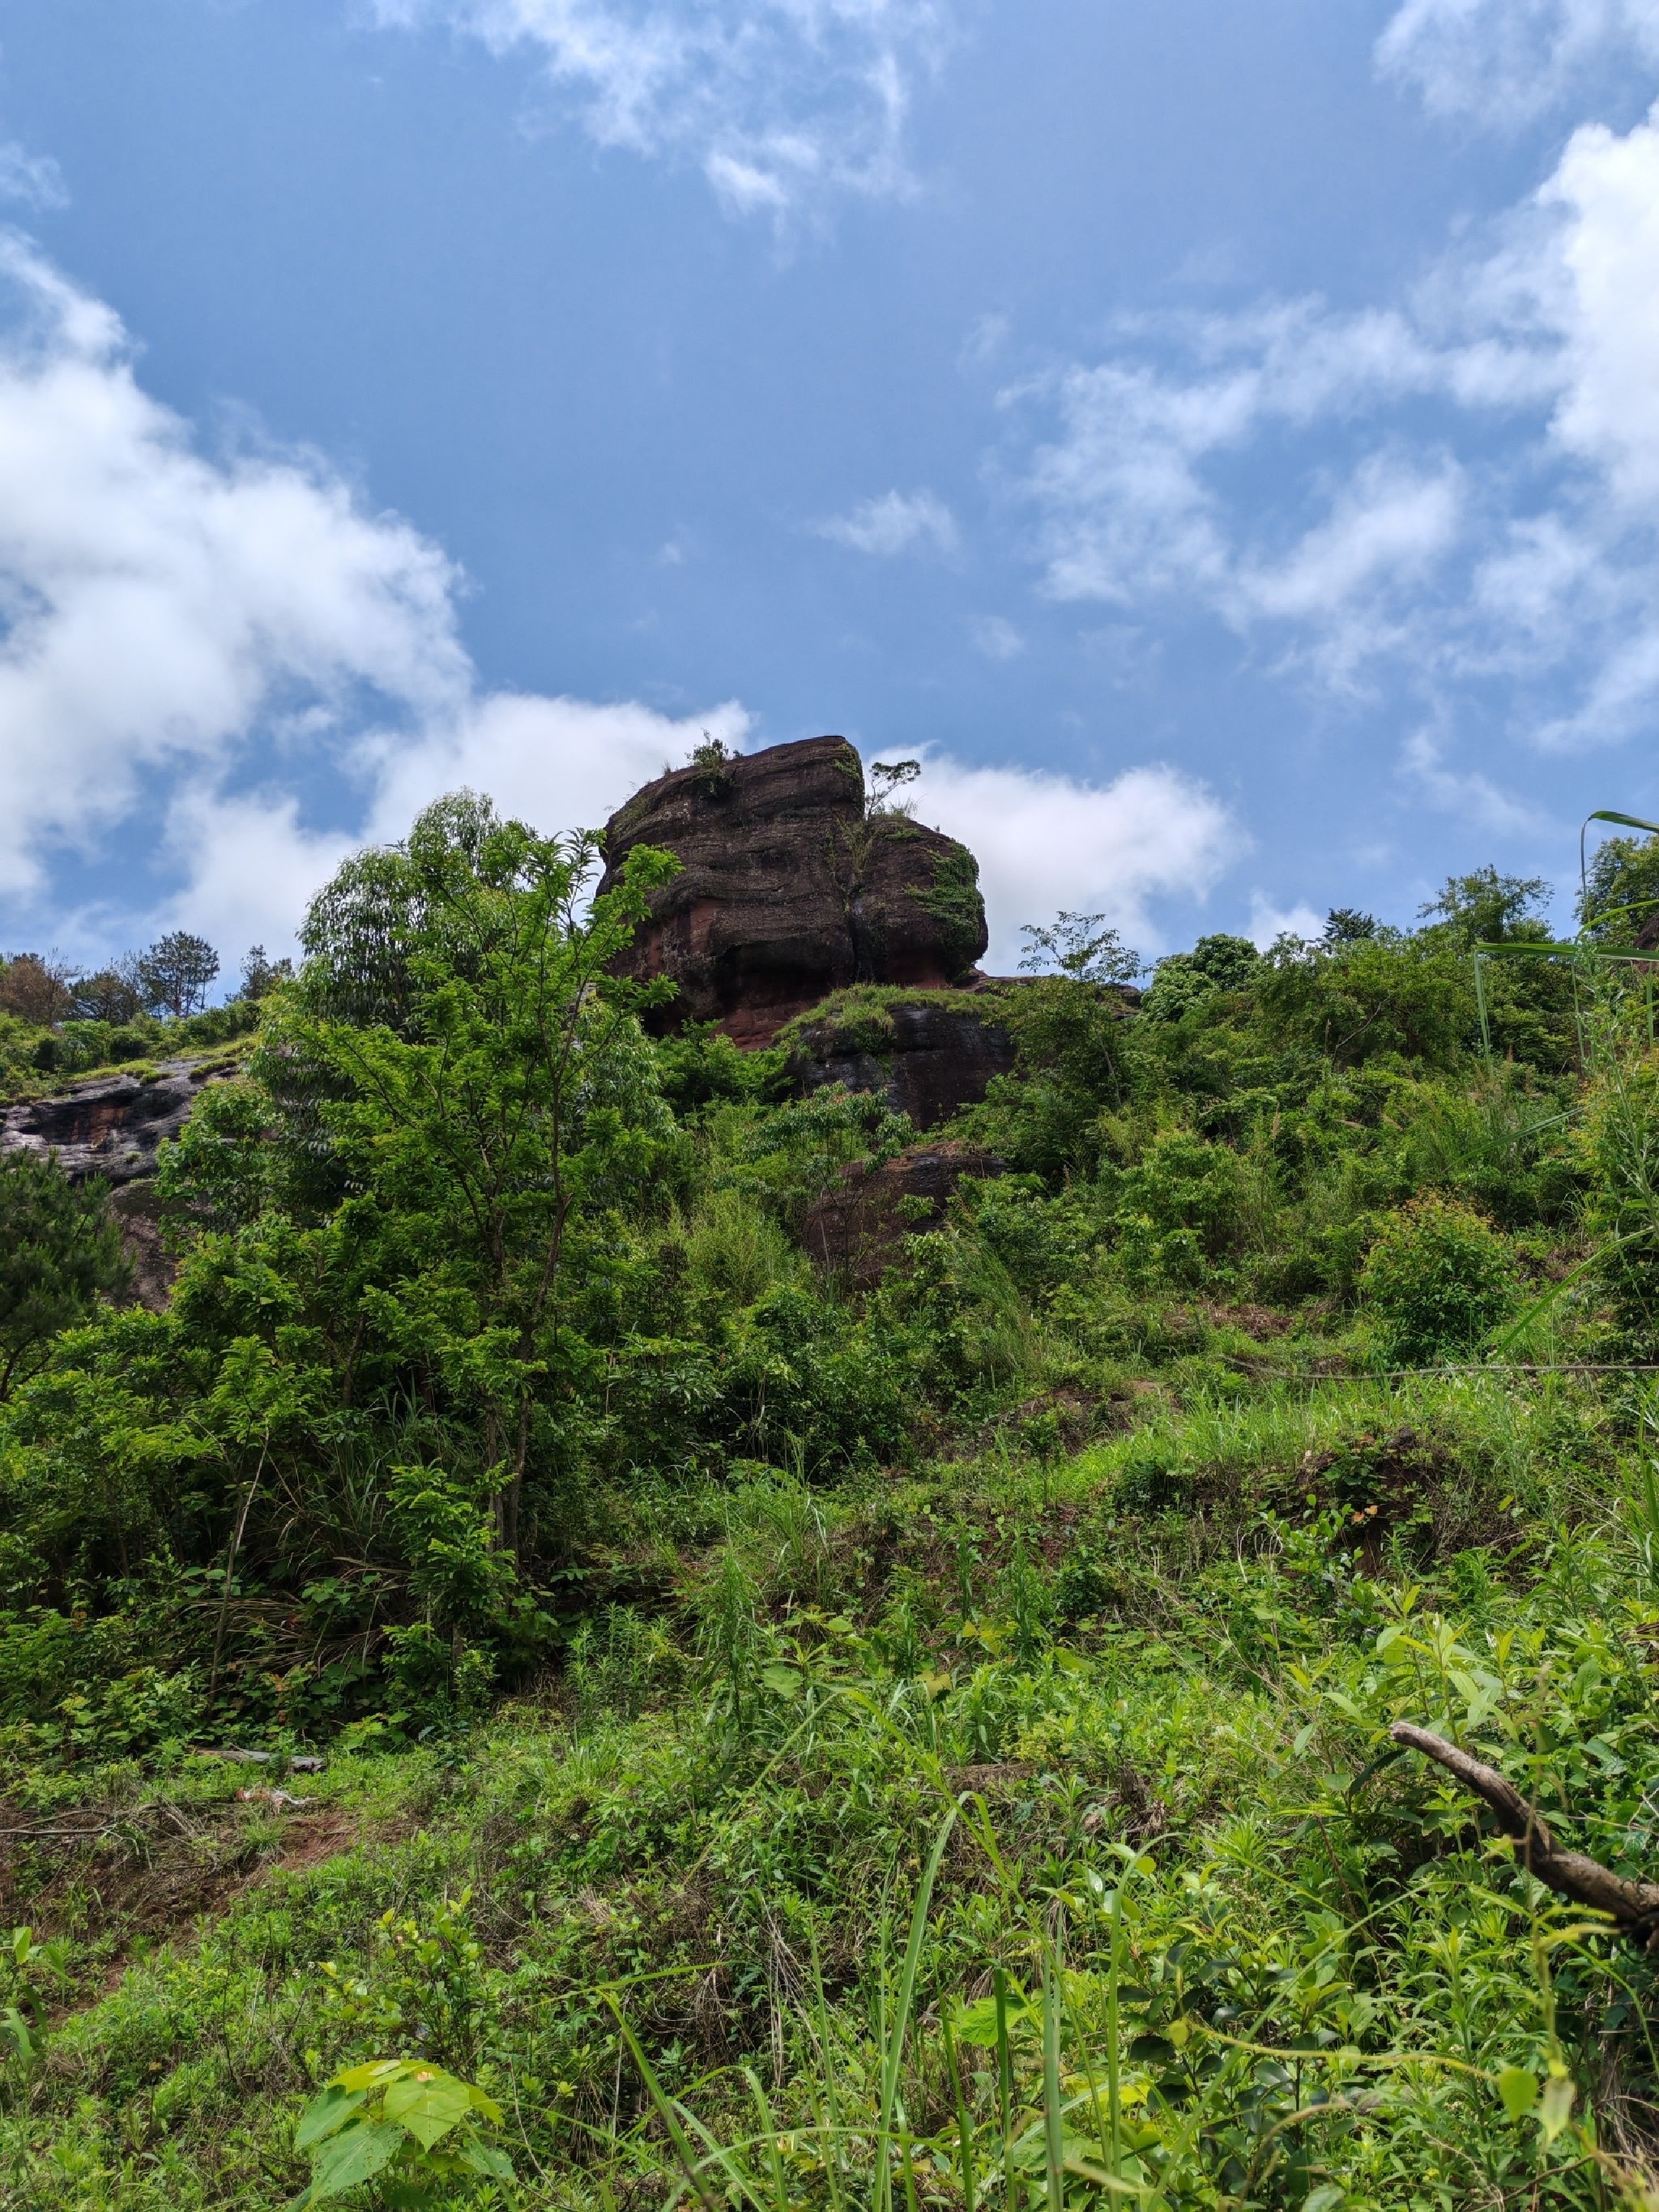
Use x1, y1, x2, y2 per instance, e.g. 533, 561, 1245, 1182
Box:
599, 737, 987, 1046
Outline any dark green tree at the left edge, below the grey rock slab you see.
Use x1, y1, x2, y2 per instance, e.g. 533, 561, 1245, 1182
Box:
0, 1152, 128, 1398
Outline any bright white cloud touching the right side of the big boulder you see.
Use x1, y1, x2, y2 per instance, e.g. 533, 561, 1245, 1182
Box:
915, 752, 1243, 973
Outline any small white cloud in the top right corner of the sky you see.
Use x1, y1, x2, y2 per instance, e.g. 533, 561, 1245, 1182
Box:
1375, 0, 1659, 126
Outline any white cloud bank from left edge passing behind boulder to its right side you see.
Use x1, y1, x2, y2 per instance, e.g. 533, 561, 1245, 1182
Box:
0, 237, 1232, 963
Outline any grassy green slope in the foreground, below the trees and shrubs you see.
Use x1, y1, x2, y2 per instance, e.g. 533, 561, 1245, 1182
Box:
0, 1354, 1659, 2212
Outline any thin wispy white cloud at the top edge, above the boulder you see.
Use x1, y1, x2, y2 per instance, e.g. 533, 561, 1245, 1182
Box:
369, 0, 956, 221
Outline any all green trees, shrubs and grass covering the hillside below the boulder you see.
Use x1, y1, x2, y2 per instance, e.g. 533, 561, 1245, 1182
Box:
0, 796, 1659, 2212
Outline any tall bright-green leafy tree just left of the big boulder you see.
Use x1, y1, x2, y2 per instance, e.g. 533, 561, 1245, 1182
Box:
168, 792, 677, 1552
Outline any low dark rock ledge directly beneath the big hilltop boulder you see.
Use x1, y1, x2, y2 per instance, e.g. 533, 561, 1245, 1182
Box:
790, 996, 1013, 1128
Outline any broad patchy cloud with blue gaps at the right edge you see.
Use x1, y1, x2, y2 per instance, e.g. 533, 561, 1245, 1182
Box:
1004, 92, 1659, 734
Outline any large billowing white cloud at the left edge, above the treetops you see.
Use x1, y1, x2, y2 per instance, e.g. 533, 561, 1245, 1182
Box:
0, 237, 471, 896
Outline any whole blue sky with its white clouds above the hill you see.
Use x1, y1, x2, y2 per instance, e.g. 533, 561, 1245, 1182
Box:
0, 0, 1659, 967
